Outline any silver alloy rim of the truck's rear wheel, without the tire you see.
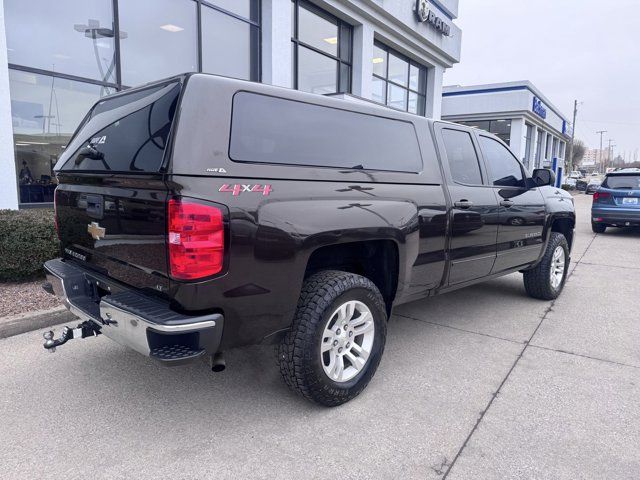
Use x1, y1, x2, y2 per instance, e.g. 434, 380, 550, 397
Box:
320, 300, 375, 383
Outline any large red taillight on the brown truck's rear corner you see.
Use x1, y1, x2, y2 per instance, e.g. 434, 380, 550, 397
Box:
168, 199, 224, 280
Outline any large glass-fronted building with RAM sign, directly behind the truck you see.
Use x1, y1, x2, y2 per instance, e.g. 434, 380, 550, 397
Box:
0, 0, 461, 209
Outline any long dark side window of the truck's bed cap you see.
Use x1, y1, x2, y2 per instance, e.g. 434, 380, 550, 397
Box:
229, 92, 422, 173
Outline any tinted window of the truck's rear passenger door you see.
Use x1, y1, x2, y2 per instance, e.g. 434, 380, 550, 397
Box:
442, 128, 482, 185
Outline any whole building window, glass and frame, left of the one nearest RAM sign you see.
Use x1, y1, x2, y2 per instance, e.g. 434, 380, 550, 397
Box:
291, 0, 352, 94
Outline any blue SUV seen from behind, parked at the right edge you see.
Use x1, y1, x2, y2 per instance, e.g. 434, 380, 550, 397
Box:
591, 168, 640, 233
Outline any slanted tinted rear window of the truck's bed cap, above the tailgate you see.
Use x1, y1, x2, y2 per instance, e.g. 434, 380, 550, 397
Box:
62, 83, 180, 172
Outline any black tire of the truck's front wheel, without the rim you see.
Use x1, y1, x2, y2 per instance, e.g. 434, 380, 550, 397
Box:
523, 232, 569, 300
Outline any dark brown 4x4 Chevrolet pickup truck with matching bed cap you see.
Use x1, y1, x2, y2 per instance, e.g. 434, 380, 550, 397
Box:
45, 74, 575, 406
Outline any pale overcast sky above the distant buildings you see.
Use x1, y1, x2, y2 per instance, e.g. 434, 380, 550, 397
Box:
444, 0, 640, 160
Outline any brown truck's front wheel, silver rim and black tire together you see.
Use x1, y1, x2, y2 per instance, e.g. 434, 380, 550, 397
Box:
524, 232, 569, 300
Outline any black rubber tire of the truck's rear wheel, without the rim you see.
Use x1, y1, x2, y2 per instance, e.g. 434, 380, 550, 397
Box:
278, 270, 387, 407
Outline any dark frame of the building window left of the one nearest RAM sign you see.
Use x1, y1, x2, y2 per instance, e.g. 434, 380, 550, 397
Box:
291, 0, 353, 93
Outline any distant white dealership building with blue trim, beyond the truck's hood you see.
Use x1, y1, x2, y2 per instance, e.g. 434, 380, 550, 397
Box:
442, 81, 571, 184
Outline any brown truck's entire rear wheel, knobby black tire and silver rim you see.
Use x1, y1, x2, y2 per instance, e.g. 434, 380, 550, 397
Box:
278, 271, 387, 407
